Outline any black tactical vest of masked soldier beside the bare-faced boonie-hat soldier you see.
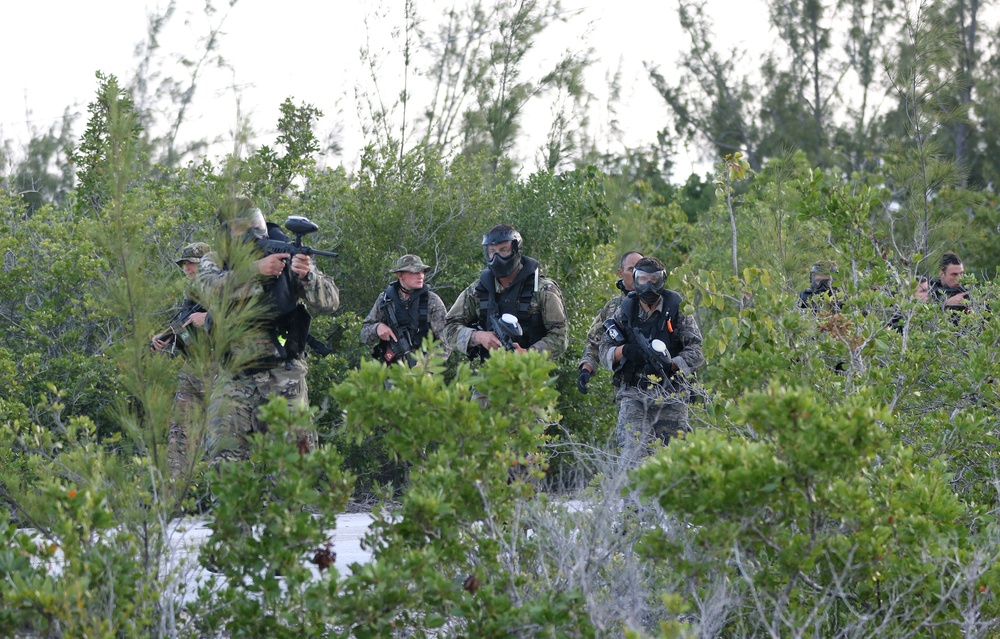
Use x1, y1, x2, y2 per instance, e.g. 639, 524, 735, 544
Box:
476, 257, 548, 348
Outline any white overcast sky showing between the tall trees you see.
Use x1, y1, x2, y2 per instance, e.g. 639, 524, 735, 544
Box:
0, 0, 773, 179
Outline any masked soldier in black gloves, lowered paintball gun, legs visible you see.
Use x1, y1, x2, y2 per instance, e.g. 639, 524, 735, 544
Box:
600, 257, 705, 465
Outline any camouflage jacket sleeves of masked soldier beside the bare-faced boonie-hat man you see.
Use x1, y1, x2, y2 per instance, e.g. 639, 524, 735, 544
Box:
444, 258, 569, 359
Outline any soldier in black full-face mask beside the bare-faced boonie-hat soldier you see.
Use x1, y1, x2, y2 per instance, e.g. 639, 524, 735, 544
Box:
444, 224, 569, 359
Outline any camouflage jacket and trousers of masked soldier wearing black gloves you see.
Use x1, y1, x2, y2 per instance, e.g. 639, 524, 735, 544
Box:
600, 296, 705, 464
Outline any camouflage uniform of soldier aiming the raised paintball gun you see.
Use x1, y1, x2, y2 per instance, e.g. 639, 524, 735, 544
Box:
198, 242, 340, 460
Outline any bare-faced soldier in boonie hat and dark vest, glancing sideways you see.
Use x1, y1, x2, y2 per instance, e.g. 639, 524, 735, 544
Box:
361, 255, 448, 364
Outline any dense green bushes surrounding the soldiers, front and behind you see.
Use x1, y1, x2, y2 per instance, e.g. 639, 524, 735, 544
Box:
0, 71, 1000, 637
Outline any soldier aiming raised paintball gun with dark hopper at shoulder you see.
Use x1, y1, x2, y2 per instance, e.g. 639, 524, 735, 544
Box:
198, 198, 340, 460
